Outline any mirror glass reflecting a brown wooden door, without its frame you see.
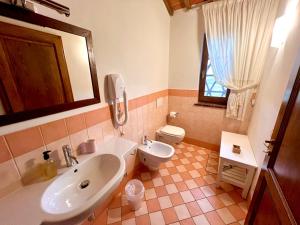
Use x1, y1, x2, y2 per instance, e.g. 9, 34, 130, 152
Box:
0, 17, 95, 115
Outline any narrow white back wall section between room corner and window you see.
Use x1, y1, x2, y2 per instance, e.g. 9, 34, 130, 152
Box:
169, 7, 205, 90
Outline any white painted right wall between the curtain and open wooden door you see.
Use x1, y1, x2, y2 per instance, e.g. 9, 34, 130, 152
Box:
248, 0, 300, 196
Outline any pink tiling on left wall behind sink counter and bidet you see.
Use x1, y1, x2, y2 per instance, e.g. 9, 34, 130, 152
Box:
0, 90, 168, 195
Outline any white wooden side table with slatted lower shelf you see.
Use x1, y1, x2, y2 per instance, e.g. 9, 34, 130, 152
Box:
217, 131, 257, 198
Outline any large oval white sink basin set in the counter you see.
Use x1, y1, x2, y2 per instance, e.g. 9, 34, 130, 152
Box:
41, 154, 125, 224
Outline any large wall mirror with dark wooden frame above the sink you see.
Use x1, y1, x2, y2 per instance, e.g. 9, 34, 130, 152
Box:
0, 3, 100, 126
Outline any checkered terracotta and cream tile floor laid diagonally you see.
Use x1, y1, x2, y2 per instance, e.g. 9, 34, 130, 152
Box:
95, 143, 248, 225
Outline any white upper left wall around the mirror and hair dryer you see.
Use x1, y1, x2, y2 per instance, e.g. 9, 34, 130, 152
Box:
0, 0, 170, 135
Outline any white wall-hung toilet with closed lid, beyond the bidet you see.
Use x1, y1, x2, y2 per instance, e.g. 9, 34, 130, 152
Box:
156, 125, 185, 145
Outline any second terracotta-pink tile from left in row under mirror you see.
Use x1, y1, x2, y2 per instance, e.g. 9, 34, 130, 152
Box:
5, 127, 44, 157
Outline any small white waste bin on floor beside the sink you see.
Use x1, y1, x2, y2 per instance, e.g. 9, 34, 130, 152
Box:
125, 179, 145, 210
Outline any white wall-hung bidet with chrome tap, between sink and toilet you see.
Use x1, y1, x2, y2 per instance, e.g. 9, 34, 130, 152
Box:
138, 141, 175, 170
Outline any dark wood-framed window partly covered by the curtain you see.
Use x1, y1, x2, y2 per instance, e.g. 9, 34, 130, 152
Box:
198, 36, 229, 107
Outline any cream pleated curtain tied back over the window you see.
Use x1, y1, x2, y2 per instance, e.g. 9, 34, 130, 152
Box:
203, 0, 279, 120
